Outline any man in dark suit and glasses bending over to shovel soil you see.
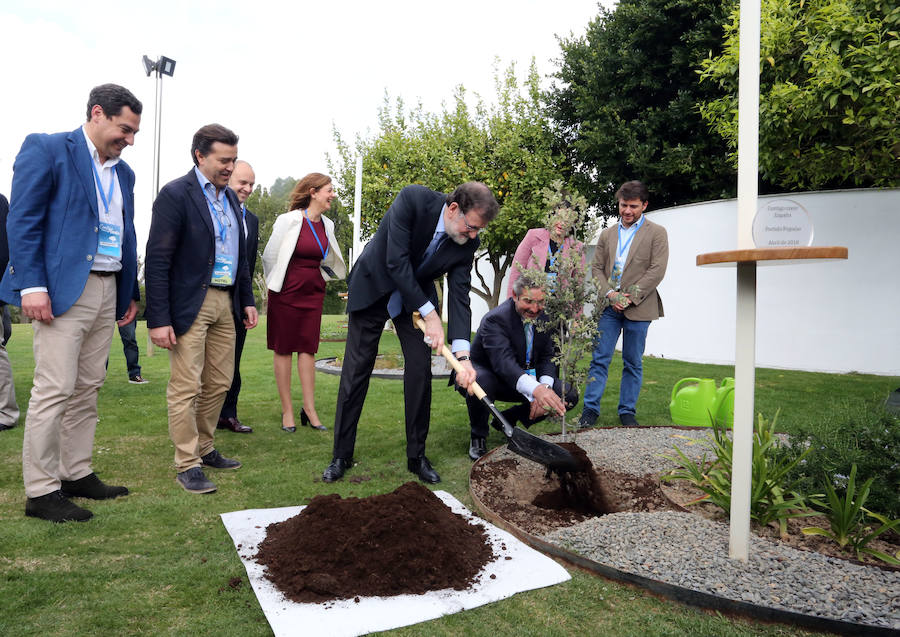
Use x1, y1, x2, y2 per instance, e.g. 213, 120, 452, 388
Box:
322, 182, 499, 484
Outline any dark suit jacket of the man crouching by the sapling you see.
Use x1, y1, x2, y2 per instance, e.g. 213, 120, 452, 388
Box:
469, 299, 556, 389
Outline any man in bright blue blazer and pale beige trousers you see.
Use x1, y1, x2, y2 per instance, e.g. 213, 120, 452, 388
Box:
0, 84, 142, 522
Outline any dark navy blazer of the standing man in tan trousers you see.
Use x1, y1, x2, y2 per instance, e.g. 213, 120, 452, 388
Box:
144, 168, 254, 336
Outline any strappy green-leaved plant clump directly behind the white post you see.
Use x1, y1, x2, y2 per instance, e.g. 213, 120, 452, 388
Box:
661, 413, 810, 536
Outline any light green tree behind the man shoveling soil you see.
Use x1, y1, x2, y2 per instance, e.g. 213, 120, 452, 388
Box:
329, 61, 565, 308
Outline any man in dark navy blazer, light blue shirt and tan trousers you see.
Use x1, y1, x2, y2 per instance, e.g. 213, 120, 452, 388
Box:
144, 124, 257, 493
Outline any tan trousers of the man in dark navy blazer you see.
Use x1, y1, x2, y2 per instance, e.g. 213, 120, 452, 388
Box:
166, 287, 235, 473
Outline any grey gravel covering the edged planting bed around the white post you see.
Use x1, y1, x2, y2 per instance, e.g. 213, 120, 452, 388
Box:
543, 428, 900, 630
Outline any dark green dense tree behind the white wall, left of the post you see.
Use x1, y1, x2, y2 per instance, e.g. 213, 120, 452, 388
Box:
547, 0, 736, 216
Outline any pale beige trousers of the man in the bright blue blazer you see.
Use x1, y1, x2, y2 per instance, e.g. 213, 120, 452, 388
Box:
22, 273, 116, 498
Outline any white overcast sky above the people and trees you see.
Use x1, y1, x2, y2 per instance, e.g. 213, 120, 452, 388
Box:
0, 0, 613, 252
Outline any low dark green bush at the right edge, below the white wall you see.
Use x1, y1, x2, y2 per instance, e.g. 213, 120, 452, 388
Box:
779, 400, 900, 518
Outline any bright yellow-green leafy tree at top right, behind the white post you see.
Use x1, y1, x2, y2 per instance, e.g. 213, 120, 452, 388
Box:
702, 0, 900, 189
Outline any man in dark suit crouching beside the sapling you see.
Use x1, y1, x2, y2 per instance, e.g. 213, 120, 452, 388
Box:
459, 270, 578, 460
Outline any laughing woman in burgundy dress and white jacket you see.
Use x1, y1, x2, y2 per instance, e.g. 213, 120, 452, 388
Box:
263, 173, 347, 433
